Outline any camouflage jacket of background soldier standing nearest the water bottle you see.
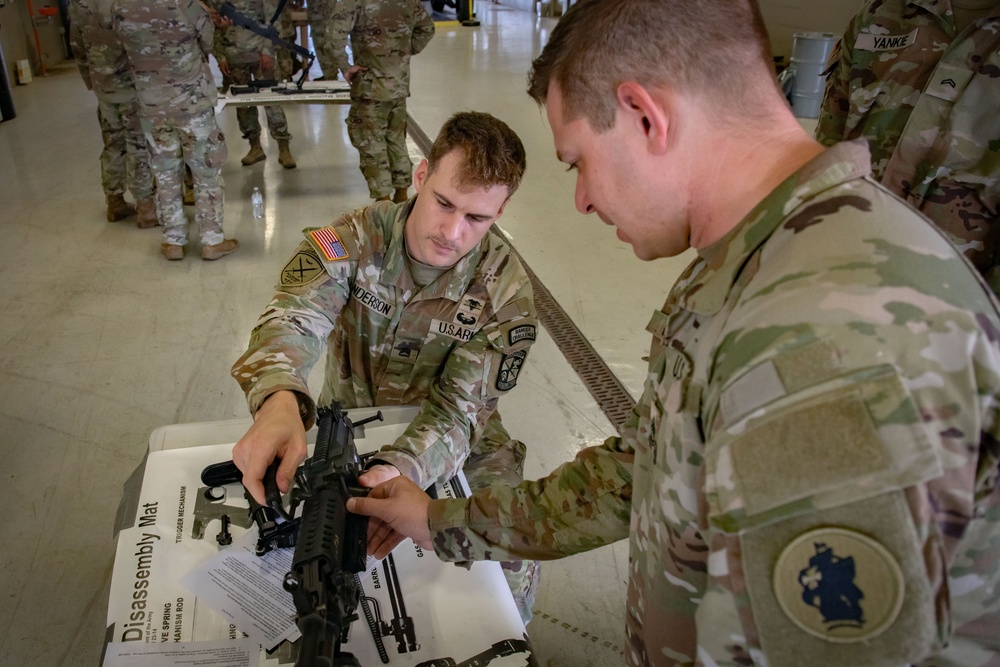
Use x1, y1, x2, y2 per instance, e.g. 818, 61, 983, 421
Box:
112, 0, 217, 116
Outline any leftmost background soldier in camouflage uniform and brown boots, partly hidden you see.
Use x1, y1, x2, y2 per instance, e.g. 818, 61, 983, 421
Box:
69, 0, 159, 229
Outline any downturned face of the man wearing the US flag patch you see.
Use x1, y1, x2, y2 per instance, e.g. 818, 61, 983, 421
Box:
406, 151, 508, 266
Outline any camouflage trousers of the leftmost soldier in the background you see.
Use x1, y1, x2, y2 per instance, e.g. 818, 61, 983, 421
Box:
97, 98, 153, 200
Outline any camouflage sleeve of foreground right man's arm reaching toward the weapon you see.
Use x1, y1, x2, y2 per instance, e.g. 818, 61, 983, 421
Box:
428, 411, 637, 561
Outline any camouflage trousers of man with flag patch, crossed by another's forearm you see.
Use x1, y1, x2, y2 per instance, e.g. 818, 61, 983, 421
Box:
462, 412, 540, 625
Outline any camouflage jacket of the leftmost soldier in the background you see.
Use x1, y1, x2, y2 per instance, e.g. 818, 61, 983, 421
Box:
69, 0, 135, 103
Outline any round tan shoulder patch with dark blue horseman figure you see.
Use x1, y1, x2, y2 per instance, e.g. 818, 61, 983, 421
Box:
773, 528, 904, 643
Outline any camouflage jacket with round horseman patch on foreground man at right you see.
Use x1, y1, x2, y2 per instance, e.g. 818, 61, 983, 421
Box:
430, 142, 1000, 667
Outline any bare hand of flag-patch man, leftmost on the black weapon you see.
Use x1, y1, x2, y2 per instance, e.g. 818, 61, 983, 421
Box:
233, 391, 308, 505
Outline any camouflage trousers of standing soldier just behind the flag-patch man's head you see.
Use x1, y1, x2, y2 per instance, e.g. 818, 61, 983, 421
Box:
347, 97, 413, 199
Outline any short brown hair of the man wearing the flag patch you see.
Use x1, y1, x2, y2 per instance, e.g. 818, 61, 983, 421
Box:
427, 111, 527, 196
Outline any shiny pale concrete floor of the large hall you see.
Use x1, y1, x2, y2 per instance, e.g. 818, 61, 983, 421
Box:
0, 2, 820, 667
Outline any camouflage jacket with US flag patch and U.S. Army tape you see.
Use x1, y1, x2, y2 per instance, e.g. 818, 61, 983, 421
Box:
232, 200, 537, 487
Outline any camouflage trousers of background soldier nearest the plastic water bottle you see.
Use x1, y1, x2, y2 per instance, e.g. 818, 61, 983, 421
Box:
142, 107, 228, 245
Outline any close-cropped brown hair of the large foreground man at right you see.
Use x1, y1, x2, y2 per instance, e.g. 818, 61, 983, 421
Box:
528, 0, 777, 132
